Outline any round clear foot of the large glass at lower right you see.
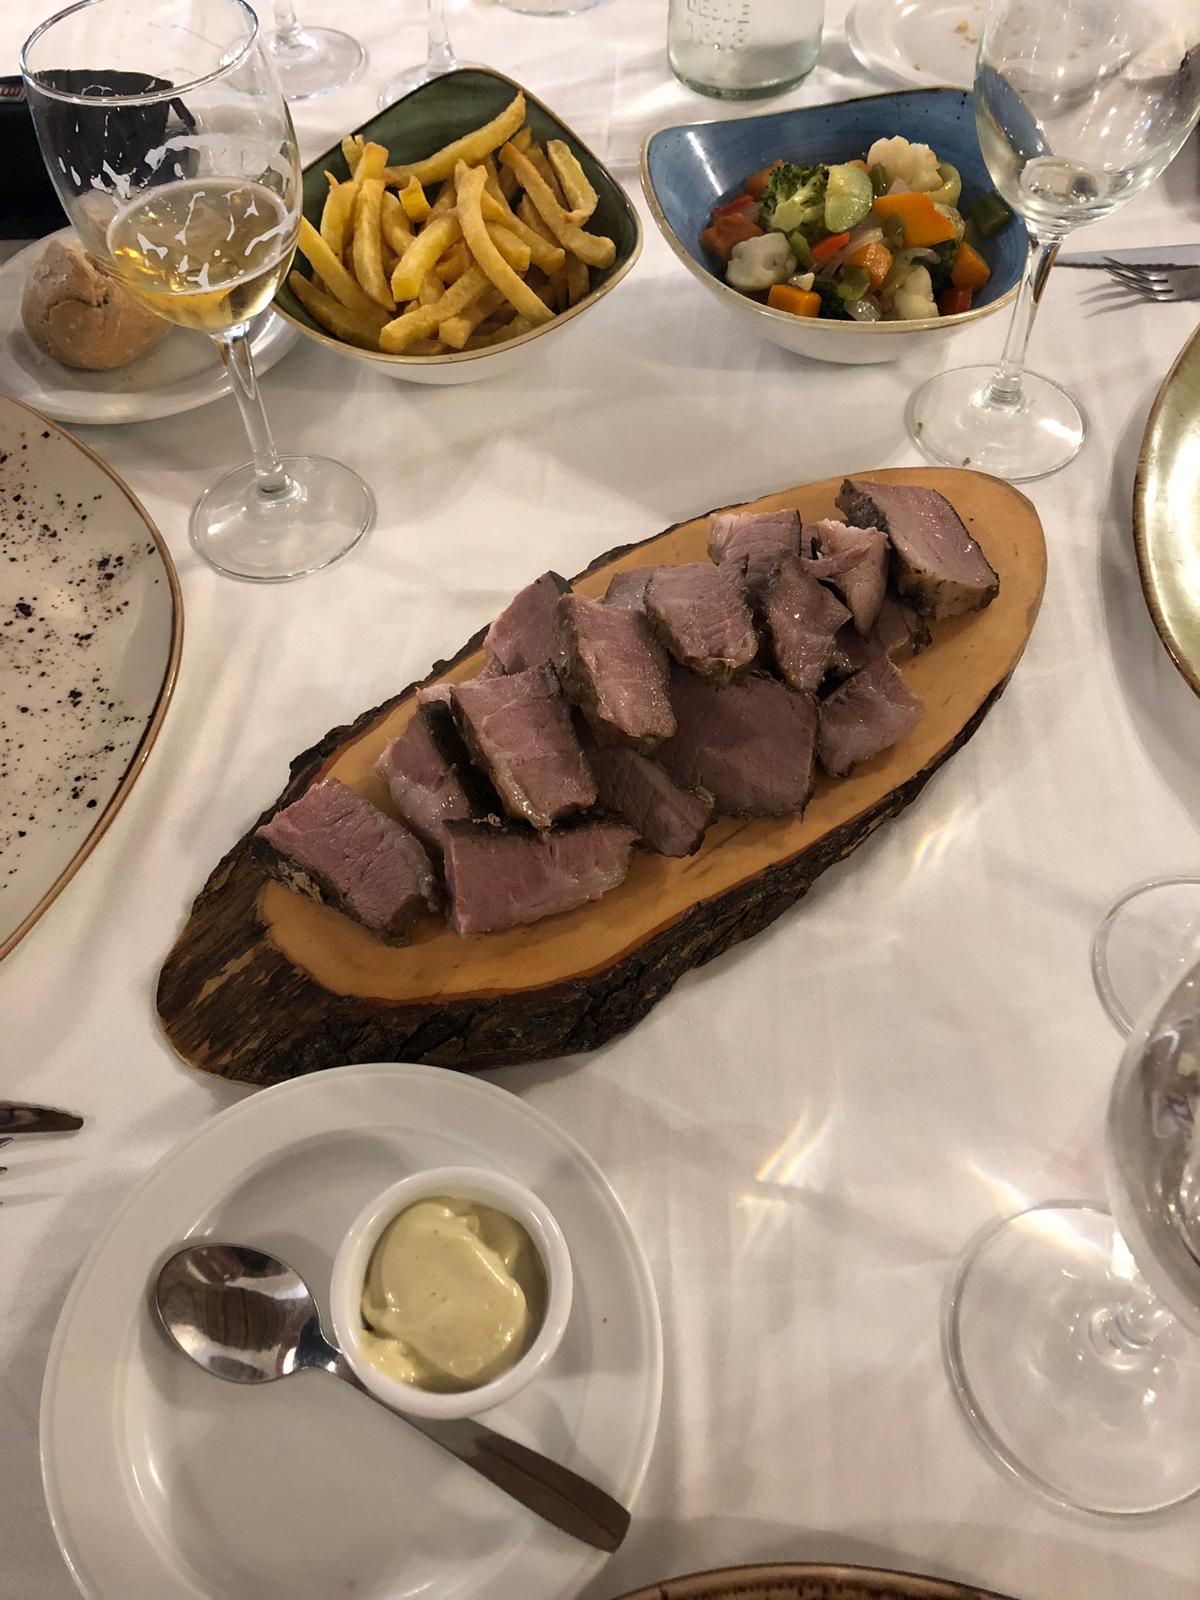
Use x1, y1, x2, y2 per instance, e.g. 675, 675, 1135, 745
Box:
942, 1202, 1200, 1517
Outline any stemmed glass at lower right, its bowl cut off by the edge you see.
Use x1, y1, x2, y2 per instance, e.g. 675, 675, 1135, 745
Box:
944, 966, 1200, 1515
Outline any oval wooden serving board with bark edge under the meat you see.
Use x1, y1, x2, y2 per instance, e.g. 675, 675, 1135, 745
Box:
158, 467, 1046, 1083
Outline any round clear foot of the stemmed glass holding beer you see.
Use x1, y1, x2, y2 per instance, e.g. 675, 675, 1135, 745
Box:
189, 456, 374, 584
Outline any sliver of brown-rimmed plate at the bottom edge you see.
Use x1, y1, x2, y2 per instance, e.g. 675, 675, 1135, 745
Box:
624, 1562, 1003, 1600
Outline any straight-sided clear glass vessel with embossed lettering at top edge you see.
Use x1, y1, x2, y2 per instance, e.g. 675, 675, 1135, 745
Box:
667, 0, 826, 99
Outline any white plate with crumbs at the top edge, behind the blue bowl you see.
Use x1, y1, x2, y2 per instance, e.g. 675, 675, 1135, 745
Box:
846, 0, 984, 90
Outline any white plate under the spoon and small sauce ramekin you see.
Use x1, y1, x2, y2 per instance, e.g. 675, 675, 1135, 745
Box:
42, 1062, 662, 1600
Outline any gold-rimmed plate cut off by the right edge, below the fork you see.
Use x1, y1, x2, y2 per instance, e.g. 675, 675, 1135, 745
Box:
1133, 328, 1200, 694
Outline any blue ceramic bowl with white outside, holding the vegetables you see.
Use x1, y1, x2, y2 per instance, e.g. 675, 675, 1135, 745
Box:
642, 90, 1027, 363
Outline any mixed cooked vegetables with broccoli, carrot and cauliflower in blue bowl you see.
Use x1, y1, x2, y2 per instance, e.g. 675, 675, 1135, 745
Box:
701, 136, 1013, 322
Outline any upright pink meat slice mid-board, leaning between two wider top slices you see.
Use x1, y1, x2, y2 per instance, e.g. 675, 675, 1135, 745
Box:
555, 595, 675, 750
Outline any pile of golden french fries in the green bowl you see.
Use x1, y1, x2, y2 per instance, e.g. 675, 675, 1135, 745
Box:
288, 91, 616, 357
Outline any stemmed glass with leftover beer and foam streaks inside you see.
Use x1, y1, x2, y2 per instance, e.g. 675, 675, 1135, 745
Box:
21, 0, 374, 581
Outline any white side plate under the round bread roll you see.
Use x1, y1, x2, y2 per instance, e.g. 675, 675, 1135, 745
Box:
0, 227, 299, 424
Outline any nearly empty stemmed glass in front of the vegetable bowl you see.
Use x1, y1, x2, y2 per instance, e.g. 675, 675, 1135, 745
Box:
907, 0, 1200, 480
